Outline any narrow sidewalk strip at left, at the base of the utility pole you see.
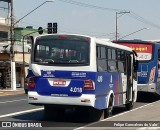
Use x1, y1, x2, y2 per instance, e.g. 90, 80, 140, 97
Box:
0, 88, 25, 96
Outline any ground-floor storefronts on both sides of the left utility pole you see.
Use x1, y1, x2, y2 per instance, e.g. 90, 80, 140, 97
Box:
0, 53, 29, 89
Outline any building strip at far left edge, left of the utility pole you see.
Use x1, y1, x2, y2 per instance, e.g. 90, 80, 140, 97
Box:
0, 0, 11, 87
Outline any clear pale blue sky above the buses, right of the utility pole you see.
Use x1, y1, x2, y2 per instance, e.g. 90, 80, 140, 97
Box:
13, 0, 160, 40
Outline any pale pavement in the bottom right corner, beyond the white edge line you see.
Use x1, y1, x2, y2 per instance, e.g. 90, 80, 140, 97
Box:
87, 100, 160, 130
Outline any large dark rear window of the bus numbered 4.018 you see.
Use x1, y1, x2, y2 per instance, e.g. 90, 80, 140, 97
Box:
33, 35, 90, 66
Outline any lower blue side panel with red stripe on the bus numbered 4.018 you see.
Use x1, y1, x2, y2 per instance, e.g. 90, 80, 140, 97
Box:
95, 72, 123, 109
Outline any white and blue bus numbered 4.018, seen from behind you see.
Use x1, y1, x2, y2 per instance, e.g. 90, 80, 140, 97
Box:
28, 34, 137, 120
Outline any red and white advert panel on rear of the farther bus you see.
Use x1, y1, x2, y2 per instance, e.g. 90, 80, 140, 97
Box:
123, 43, 153, 62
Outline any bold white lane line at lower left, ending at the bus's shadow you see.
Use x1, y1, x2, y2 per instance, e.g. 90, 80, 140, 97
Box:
0, 107, 44, 118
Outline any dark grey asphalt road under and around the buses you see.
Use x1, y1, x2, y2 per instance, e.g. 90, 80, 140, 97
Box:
0, 93, 160, 129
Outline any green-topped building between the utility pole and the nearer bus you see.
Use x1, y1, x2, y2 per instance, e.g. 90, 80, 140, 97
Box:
13, 26, 39, 87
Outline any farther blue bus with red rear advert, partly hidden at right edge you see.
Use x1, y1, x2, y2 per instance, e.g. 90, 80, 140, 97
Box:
114, 40, 160, 94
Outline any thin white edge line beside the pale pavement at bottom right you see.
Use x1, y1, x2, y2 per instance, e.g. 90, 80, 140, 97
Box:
73, 100, 160, 130
